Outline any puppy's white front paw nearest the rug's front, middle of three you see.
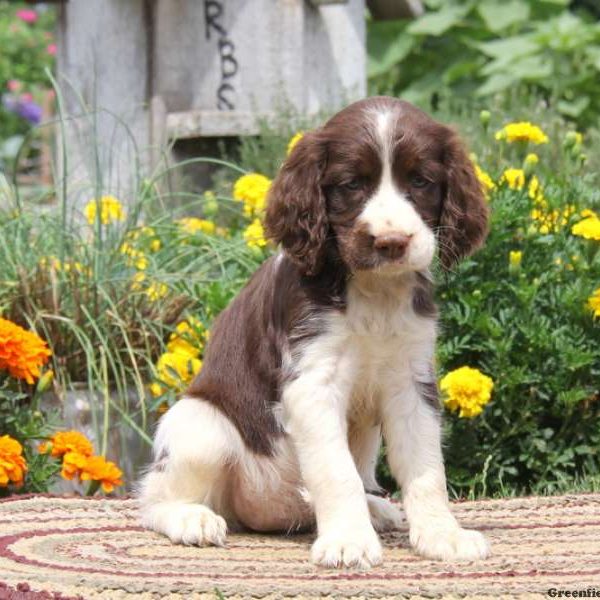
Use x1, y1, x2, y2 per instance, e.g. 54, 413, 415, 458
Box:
312, 524, 381, 568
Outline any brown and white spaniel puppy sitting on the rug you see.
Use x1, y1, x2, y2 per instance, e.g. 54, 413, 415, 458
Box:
139, 97, 489, 567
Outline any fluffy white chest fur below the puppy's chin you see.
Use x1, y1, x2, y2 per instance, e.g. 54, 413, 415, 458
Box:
292, 278, 436, 426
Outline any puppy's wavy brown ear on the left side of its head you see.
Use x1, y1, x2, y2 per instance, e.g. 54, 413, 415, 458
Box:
265, 131, 329, 275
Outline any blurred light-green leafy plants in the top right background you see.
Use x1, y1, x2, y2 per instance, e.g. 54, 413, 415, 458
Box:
368, 0, 600, 126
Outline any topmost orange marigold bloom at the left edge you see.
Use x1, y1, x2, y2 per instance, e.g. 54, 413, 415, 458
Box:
0, 318, 52, 385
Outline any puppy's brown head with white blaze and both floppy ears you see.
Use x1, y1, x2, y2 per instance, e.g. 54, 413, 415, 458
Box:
266, 97, 488, 275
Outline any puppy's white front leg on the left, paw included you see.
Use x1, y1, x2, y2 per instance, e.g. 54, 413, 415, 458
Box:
283, 365, 381, 567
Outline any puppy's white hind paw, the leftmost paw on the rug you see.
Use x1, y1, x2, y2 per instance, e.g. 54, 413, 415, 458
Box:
162, 504, 227, 546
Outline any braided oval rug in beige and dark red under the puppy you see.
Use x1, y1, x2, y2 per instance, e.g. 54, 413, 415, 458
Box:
0, 494, 600, 600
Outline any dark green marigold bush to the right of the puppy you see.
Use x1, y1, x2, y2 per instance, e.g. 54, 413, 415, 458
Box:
438, 136, 600, 495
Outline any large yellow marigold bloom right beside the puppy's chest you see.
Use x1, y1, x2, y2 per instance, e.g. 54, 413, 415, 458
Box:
440, 367, 494, 418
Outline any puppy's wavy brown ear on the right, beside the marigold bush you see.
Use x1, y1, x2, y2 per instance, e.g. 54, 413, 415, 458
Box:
438, 130, 489, 269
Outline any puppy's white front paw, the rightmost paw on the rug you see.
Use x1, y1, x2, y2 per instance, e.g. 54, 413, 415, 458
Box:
410, 524, 490, 560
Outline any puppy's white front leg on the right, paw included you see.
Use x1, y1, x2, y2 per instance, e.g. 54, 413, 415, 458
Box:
384, 386, 489, 560
